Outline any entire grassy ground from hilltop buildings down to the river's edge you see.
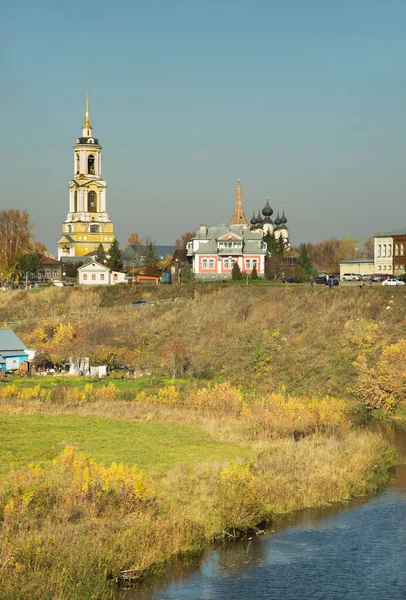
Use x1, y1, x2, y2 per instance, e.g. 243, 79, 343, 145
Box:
0, 284, 406, 600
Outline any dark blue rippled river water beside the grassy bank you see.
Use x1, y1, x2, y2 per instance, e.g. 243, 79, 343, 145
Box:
121, 428, 406, 600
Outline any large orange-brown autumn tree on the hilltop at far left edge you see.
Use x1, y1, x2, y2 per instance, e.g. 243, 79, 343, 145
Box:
0, 208, 32, 282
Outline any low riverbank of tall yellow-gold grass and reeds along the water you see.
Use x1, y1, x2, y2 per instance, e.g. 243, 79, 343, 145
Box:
0, 399, 395, 600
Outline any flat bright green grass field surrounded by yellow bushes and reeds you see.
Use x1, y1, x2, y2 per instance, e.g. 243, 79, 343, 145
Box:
0, 414, 248, 474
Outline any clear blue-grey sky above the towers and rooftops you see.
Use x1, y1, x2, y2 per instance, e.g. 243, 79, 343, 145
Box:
0, 0, 406, 252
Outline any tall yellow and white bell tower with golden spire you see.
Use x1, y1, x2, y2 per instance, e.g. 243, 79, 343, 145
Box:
57, 91, 114, 261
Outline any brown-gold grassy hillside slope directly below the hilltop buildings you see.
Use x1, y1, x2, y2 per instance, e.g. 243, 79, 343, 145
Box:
4, 285, 406, 396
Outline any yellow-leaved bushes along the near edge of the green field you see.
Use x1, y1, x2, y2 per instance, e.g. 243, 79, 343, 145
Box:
0, 446, 153, 527
